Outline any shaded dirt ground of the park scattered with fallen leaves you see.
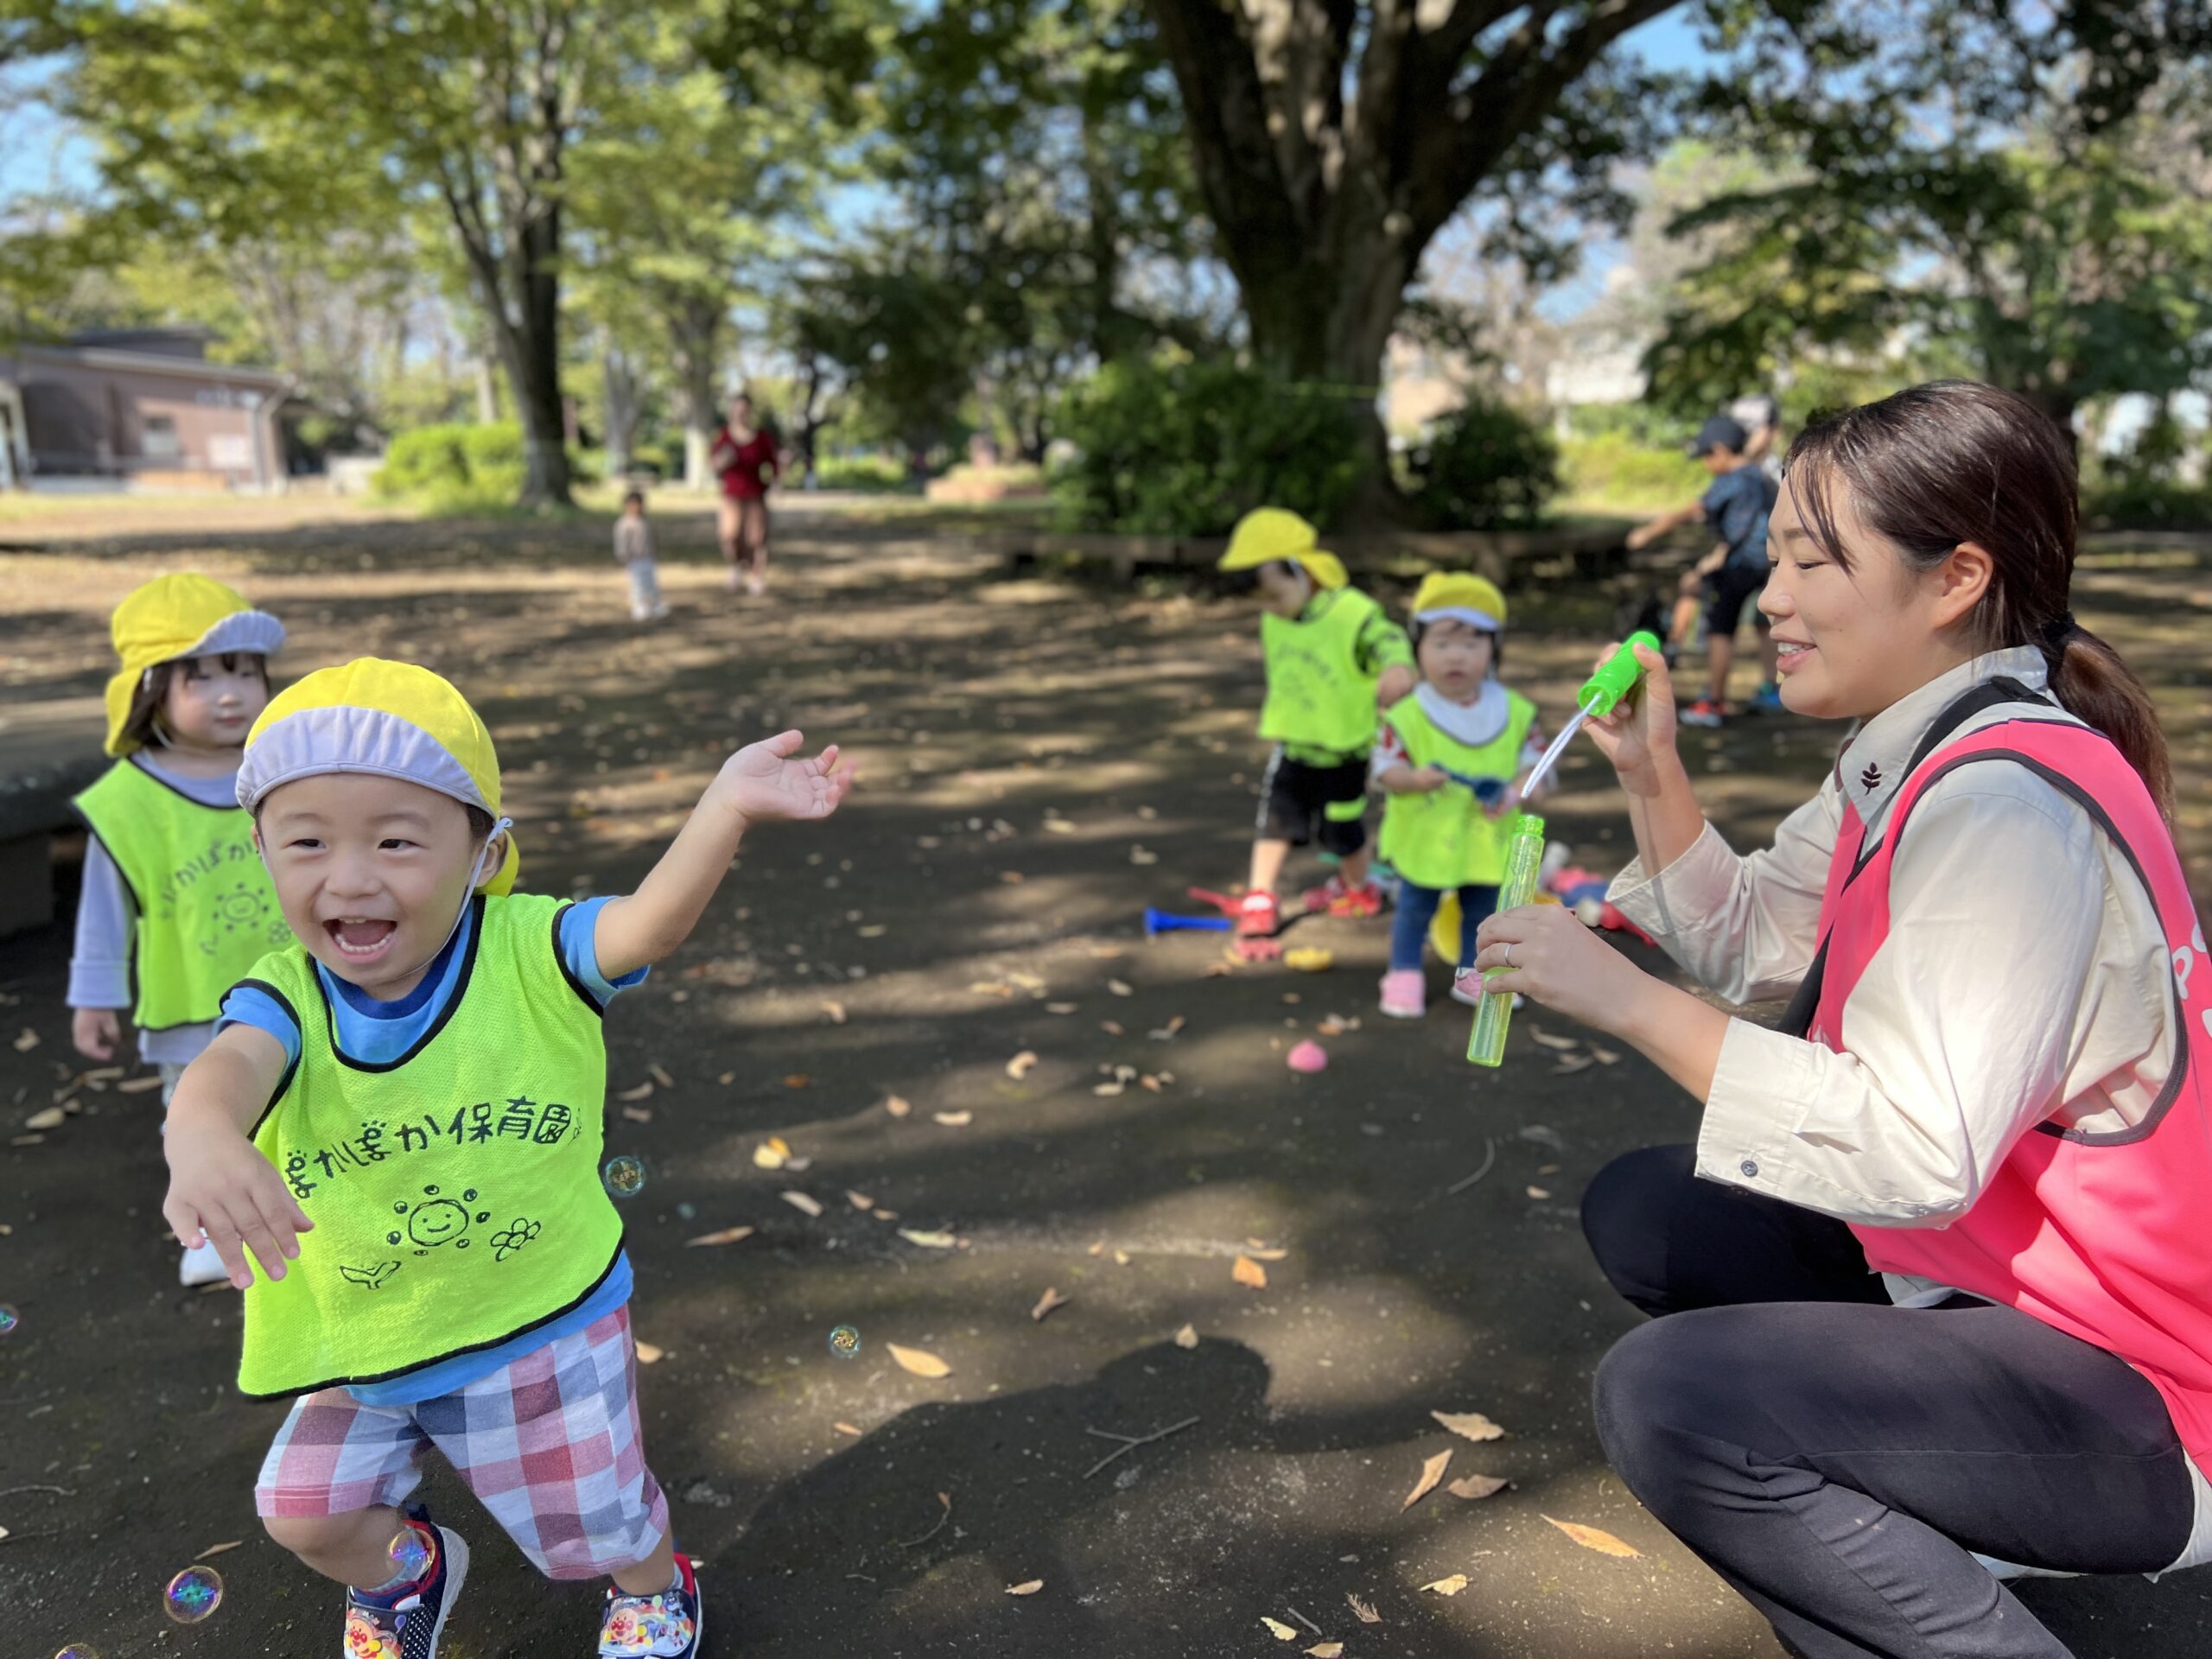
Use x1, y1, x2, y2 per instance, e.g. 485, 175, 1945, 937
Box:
0, 509, 2212, 1659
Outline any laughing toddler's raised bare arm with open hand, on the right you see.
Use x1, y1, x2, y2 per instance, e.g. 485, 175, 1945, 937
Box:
591, 732, 852, 980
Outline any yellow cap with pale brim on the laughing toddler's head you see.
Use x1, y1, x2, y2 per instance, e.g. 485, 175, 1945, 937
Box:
238, 657, 522, 893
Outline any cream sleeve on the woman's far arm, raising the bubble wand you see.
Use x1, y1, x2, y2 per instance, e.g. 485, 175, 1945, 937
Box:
1606, 779, 1842, 1002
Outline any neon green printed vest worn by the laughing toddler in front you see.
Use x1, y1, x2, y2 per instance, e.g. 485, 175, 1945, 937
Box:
238, 893, 621, 1398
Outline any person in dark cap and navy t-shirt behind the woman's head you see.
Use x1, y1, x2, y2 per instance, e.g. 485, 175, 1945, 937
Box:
1628, 416, 1783, 726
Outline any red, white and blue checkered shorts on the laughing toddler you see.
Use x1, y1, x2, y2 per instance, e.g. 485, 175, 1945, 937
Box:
254, 1307, 668, 1580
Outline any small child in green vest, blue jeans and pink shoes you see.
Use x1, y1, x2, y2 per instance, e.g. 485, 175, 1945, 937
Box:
1374, 570, 1544, 1020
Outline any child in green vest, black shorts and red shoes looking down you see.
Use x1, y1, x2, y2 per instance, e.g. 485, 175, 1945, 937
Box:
1219, 506, 1414, 940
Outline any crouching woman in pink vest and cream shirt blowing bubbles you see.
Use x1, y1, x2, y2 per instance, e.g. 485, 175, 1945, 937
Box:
1476, 383, 2212, 1659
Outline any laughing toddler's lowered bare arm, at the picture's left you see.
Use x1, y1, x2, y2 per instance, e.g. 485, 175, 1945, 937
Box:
162, 1027, 315, 1289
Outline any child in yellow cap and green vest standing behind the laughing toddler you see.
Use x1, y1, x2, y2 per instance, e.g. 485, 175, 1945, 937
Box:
68, 575, 289, 1285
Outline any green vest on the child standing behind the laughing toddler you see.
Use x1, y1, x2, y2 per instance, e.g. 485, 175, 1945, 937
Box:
75, 759, 292, 1031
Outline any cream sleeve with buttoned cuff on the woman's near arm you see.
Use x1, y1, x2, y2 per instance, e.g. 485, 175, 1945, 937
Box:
1697, 763, 2106, 1225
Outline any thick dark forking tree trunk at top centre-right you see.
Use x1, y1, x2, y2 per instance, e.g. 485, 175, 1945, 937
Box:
1146, 0, 1681, 511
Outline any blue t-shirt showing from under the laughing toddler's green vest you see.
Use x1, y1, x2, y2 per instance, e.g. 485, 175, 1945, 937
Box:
217, 898, 651, 1405
